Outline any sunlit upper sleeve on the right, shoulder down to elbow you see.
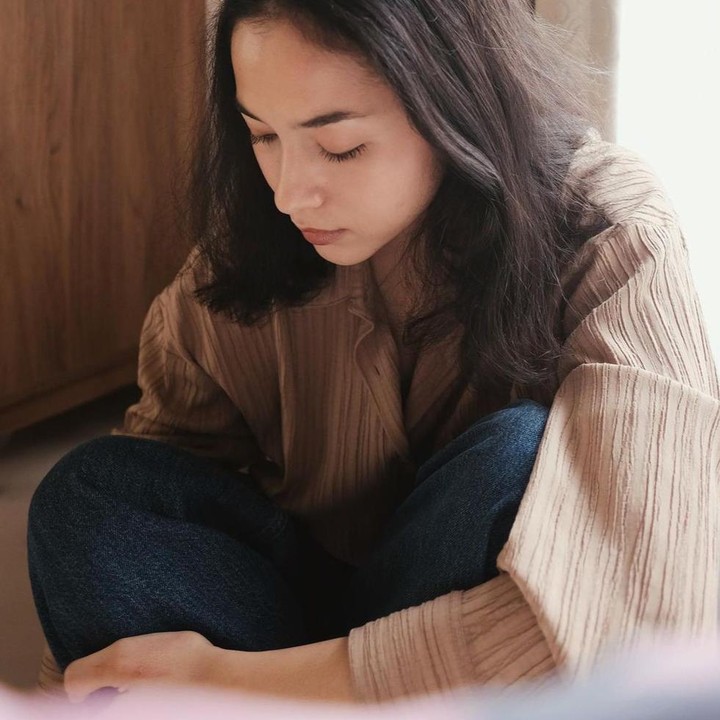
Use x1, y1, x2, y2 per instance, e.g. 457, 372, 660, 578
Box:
500, 223, 720, 673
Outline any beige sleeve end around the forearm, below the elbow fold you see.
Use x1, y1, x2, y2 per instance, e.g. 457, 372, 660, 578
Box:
349, 574, 556, 703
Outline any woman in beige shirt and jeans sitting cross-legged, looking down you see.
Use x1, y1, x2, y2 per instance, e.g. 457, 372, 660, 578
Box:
29, 0, 720, 701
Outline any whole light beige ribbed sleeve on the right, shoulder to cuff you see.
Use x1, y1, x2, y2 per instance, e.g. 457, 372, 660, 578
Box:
350, 223, 720, 702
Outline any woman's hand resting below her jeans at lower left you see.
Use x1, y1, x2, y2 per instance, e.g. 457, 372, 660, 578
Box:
65, 630, 218, 703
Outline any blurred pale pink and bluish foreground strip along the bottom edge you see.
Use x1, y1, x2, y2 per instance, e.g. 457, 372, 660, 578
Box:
0, 638, 720, 720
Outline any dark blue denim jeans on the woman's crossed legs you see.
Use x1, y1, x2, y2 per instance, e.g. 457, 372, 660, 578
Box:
28, 400, 548, 670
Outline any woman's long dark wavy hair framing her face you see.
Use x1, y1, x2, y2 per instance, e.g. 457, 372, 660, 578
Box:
190, 0, 606, 388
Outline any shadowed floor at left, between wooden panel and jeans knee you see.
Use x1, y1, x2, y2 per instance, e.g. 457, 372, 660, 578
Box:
0, 386, 139, 688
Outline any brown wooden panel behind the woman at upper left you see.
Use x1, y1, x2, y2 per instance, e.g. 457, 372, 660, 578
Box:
0, 0, 205, 432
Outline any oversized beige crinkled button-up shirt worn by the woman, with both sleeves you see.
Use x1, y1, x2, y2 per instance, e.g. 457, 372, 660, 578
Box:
116, 135, 720, 701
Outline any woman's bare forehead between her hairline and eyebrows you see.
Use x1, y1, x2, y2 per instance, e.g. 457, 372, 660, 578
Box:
231, 20, 392, 111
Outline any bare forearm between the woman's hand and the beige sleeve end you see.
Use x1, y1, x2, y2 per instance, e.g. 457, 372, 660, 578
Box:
202, 637, 356, 702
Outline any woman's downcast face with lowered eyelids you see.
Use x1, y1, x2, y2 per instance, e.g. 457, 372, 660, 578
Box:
232, 21, 442, 265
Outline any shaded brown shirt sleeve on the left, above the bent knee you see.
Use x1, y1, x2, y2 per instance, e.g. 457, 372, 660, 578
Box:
112, 255, 261, 468
